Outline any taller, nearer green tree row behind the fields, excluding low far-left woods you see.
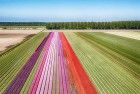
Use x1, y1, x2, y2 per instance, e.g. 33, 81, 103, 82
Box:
46, 21, 140, 29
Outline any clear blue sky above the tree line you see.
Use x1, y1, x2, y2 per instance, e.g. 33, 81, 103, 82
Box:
0, 0, 140, 21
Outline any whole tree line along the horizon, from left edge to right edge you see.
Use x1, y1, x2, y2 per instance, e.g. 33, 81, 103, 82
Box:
0, 21, 140, 29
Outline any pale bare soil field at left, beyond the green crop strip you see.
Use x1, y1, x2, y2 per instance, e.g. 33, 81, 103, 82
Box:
0, 30, 41, 52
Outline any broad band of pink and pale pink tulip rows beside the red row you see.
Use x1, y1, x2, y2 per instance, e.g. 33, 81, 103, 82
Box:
28, 33, 70, 94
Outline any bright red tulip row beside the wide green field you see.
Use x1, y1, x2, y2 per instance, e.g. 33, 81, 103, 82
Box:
60, 33, 97, 94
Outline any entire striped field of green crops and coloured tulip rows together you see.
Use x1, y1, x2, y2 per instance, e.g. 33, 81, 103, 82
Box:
0, 32, 140, 94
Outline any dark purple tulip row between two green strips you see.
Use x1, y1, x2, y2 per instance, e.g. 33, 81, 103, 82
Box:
4, 33, 51, 94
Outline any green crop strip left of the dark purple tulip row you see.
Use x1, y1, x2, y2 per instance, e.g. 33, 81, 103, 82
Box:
0, 33, 45, 92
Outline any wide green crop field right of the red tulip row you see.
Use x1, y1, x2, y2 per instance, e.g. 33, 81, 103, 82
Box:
65, 32, 140, 94
